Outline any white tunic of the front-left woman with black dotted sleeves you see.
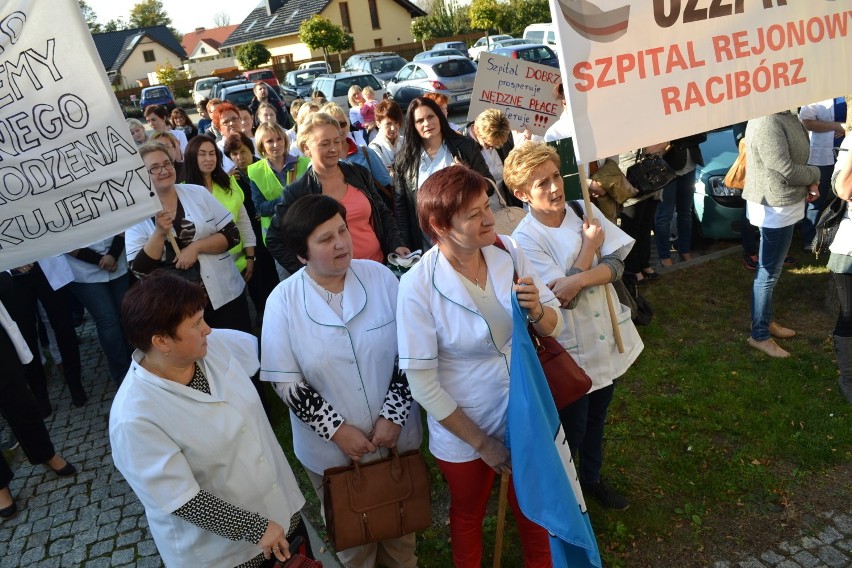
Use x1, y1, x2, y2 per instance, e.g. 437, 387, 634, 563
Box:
109, 329, 305, 568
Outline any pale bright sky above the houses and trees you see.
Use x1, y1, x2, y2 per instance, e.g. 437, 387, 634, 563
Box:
86, 0, 259, 33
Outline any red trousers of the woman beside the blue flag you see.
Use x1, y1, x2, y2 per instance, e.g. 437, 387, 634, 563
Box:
437, 459, 552, 568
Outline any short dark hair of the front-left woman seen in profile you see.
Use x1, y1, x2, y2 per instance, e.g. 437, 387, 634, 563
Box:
121, 269, 207, 353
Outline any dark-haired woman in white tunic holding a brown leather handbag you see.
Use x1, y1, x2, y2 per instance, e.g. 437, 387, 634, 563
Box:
261, 195, 421, 568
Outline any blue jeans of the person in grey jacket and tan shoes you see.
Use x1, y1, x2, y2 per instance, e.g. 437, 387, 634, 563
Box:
751, 225, 795, 341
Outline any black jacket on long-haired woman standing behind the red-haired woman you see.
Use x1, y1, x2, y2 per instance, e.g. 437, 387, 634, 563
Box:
394, 134, 494, 250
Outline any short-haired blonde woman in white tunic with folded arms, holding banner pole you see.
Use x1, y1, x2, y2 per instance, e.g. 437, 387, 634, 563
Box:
503, 142, 643, 510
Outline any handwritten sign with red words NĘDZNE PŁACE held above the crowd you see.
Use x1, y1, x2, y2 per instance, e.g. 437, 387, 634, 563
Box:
467, 53, 562, 135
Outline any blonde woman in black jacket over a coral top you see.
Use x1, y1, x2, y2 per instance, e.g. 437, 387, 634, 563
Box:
266, 112, 409, 274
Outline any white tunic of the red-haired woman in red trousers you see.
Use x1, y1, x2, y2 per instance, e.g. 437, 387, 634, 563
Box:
397, 236, 559, 463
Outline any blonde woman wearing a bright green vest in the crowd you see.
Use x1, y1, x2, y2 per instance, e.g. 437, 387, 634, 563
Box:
248, 122, 309, 246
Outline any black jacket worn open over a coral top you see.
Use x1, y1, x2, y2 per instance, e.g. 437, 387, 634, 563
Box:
266, 162, 403, 274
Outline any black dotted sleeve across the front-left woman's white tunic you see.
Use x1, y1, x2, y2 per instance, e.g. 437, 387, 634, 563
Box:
172, 489, 269, 544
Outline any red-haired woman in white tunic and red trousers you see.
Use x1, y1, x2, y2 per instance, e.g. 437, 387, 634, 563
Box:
397, 166, 562, 568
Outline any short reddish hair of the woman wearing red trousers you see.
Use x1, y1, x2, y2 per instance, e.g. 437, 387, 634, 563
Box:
417, 165, 488, 241
